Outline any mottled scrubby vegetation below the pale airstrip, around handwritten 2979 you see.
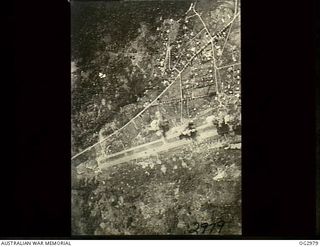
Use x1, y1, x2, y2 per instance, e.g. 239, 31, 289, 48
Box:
73, 136, 241, 235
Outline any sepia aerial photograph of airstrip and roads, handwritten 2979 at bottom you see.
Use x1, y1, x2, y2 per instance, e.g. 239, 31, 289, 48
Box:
70, 0, 242, 236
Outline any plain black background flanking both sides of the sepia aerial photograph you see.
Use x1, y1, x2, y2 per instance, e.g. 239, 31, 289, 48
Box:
6, 0, 320, 239
